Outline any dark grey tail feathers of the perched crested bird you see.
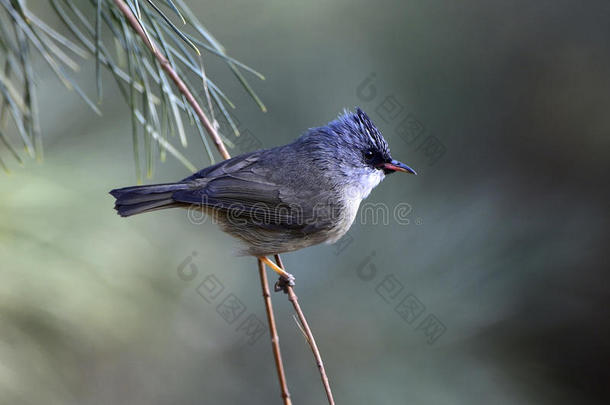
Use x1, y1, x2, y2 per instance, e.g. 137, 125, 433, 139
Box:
110, 183, 188, 217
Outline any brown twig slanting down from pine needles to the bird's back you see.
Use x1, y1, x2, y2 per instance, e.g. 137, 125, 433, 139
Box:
114, 0, 231, 159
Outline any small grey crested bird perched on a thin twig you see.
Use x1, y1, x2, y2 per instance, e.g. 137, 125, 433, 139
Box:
110, 107, 417, 285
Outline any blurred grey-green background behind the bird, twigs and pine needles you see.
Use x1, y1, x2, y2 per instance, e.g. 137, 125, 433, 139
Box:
0, 0, 610, 404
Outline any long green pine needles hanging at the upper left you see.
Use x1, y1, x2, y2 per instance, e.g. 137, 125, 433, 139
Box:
0, 0, 266, 172
